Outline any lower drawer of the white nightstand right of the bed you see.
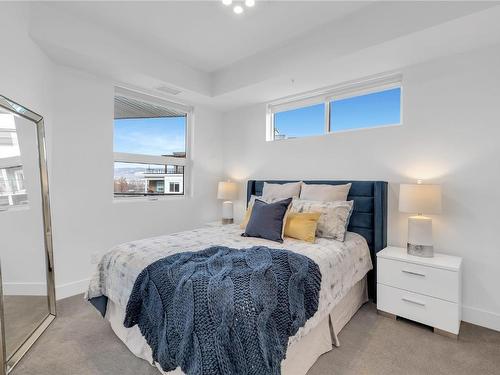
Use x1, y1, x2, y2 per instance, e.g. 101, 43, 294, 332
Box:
377, 284, 460, 334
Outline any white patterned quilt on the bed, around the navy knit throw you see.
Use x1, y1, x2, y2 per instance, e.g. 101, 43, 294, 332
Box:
87, 225, 372, 345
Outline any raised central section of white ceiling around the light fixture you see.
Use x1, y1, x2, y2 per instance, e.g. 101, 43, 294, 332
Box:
46, 0, 370, 72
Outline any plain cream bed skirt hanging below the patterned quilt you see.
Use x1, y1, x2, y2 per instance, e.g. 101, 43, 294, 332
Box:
106, 276, 368, 375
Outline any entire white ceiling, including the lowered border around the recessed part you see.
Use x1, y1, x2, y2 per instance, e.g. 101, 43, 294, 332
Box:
34, 0, 500, 111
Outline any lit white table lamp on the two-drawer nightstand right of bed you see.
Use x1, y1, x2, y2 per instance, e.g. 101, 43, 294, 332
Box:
399, 184, 441, 258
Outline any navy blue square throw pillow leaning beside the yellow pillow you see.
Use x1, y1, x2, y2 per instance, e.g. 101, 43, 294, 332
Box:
242, 198, 292, 243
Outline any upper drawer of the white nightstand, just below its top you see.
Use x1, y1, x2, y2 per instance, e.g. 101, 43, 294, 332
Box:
377, 257, 460, 302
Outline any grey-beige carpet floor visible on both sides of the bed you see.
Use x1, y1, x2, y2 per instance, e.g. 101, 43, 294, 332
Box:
11, 296, 500, 375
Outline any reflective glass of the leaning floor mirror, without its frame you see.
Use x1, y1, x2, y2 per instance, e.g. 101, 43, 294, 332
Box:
0, 109, 49, 359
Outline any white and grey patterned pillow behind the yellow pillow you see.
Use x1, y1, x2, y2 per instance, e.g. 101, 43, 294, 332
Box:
291, 199, 354, 241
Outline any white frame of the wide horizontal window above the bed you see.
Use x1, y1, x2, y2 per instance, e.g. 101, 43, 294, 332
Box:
266, 73, 403, 141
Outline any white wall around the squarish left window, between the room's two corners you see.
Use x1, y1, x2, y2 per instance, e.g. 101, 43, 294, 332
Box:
51, 67, 222, 298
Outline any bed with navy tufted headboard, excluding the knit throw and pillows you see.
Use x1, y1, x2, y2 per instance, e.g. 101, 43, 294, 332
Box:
86, 180, 387, 375
